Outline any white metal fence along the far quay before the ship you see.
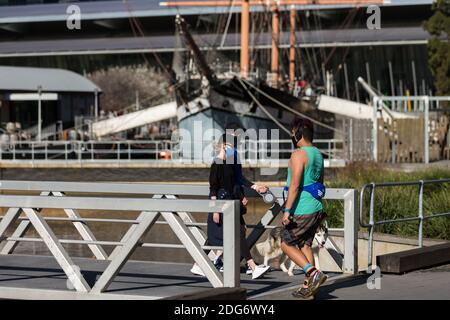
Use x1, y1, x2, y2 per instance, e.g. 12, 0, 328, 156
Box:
0, 139, 344, 163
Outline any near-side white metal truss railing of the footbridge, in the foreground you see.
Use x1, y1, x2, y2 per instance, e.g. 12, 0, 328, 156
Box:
0, 190, 240, 294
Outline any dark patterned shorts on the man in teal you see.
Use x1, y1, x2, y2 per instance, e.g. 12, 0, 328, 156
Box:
281, 211, 326, 248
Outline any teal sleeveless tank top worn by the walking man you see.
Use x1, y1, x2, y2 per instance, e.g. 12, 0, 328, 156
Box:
286, 146, 323, 215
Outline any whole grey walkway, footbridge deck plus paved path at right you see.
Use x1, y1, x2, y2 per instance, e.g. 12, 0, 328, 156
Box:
0, 255, 450, 300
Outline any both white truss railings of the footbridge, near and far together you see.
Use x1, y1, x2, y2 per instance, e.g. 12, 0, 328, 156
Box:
0, 181, 358, 294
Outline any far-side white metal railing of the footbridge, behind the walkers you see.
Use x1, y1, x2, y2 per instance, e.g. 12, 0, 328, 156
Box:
0, 180, 357, 273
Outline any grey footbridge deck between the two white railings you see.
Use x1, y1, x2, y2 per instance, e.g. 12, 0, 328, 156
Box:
0, 255, 336, 299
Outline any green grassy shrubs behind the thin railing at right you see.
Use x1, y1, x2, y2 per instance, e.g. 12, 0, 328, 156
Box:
324, 163, 450, 239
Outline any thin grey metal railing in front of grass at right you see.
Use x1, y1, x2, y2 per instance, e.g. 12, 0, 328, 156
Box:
359, 179, 450, 271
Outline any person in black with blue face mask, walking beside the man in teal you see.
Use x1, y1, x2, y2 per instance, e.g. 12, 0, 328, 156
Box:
191, 134, 270, 279
